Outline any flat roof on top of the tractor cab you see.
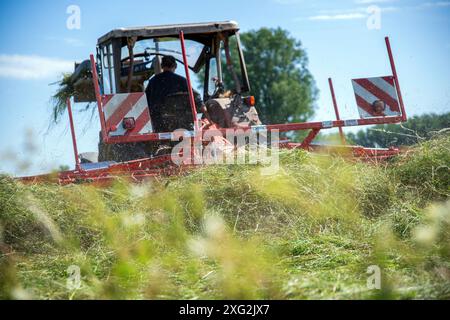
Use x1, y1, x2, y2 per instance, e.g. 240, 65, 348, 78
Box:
98, 21, 239, 45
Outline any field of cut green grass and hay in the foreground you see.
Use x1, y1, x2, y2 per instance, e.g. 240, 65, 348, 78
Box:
0, 136, 450, 299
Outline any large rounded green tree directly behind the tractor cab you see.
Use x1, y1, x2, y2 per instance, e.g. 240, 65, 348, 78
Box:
224, 28, 318, 124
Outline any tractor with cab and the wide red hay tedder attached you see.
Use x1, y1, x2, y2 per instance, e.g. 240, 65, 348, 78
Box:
20, 21, 406, 185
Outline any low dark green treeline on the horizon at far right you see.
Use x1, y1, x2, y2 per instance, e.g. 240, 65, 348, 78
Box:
347, 112, 450, 147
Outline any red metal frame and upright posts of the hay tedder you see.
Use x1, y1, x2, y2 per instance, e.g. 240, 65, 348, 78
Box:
16, 36, 407, 184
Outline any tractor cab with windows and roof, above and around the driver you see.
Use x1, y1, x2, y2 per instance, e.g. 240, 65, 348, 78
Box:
97, 22, 250, 97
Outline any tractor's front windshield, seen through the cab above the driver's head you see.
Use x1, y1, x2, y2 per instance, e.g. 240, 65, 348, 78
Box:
122, 38, 205, 68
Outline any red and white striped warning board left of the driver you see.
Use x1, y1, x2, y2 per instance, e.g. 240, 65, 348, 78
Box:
102, 92, 153, 136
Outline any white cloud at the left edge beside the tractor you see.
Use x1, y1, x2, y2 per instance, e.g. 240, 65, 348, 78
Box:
0, 54, 74, 80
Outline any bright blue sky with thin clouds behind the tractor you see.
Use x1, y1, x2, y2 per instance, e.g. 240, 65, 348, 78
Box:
0, 0, 450, 175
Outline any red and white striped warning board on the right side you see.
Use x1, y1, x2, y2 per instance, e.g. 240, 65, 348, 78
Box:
352, 77, 401, 118
